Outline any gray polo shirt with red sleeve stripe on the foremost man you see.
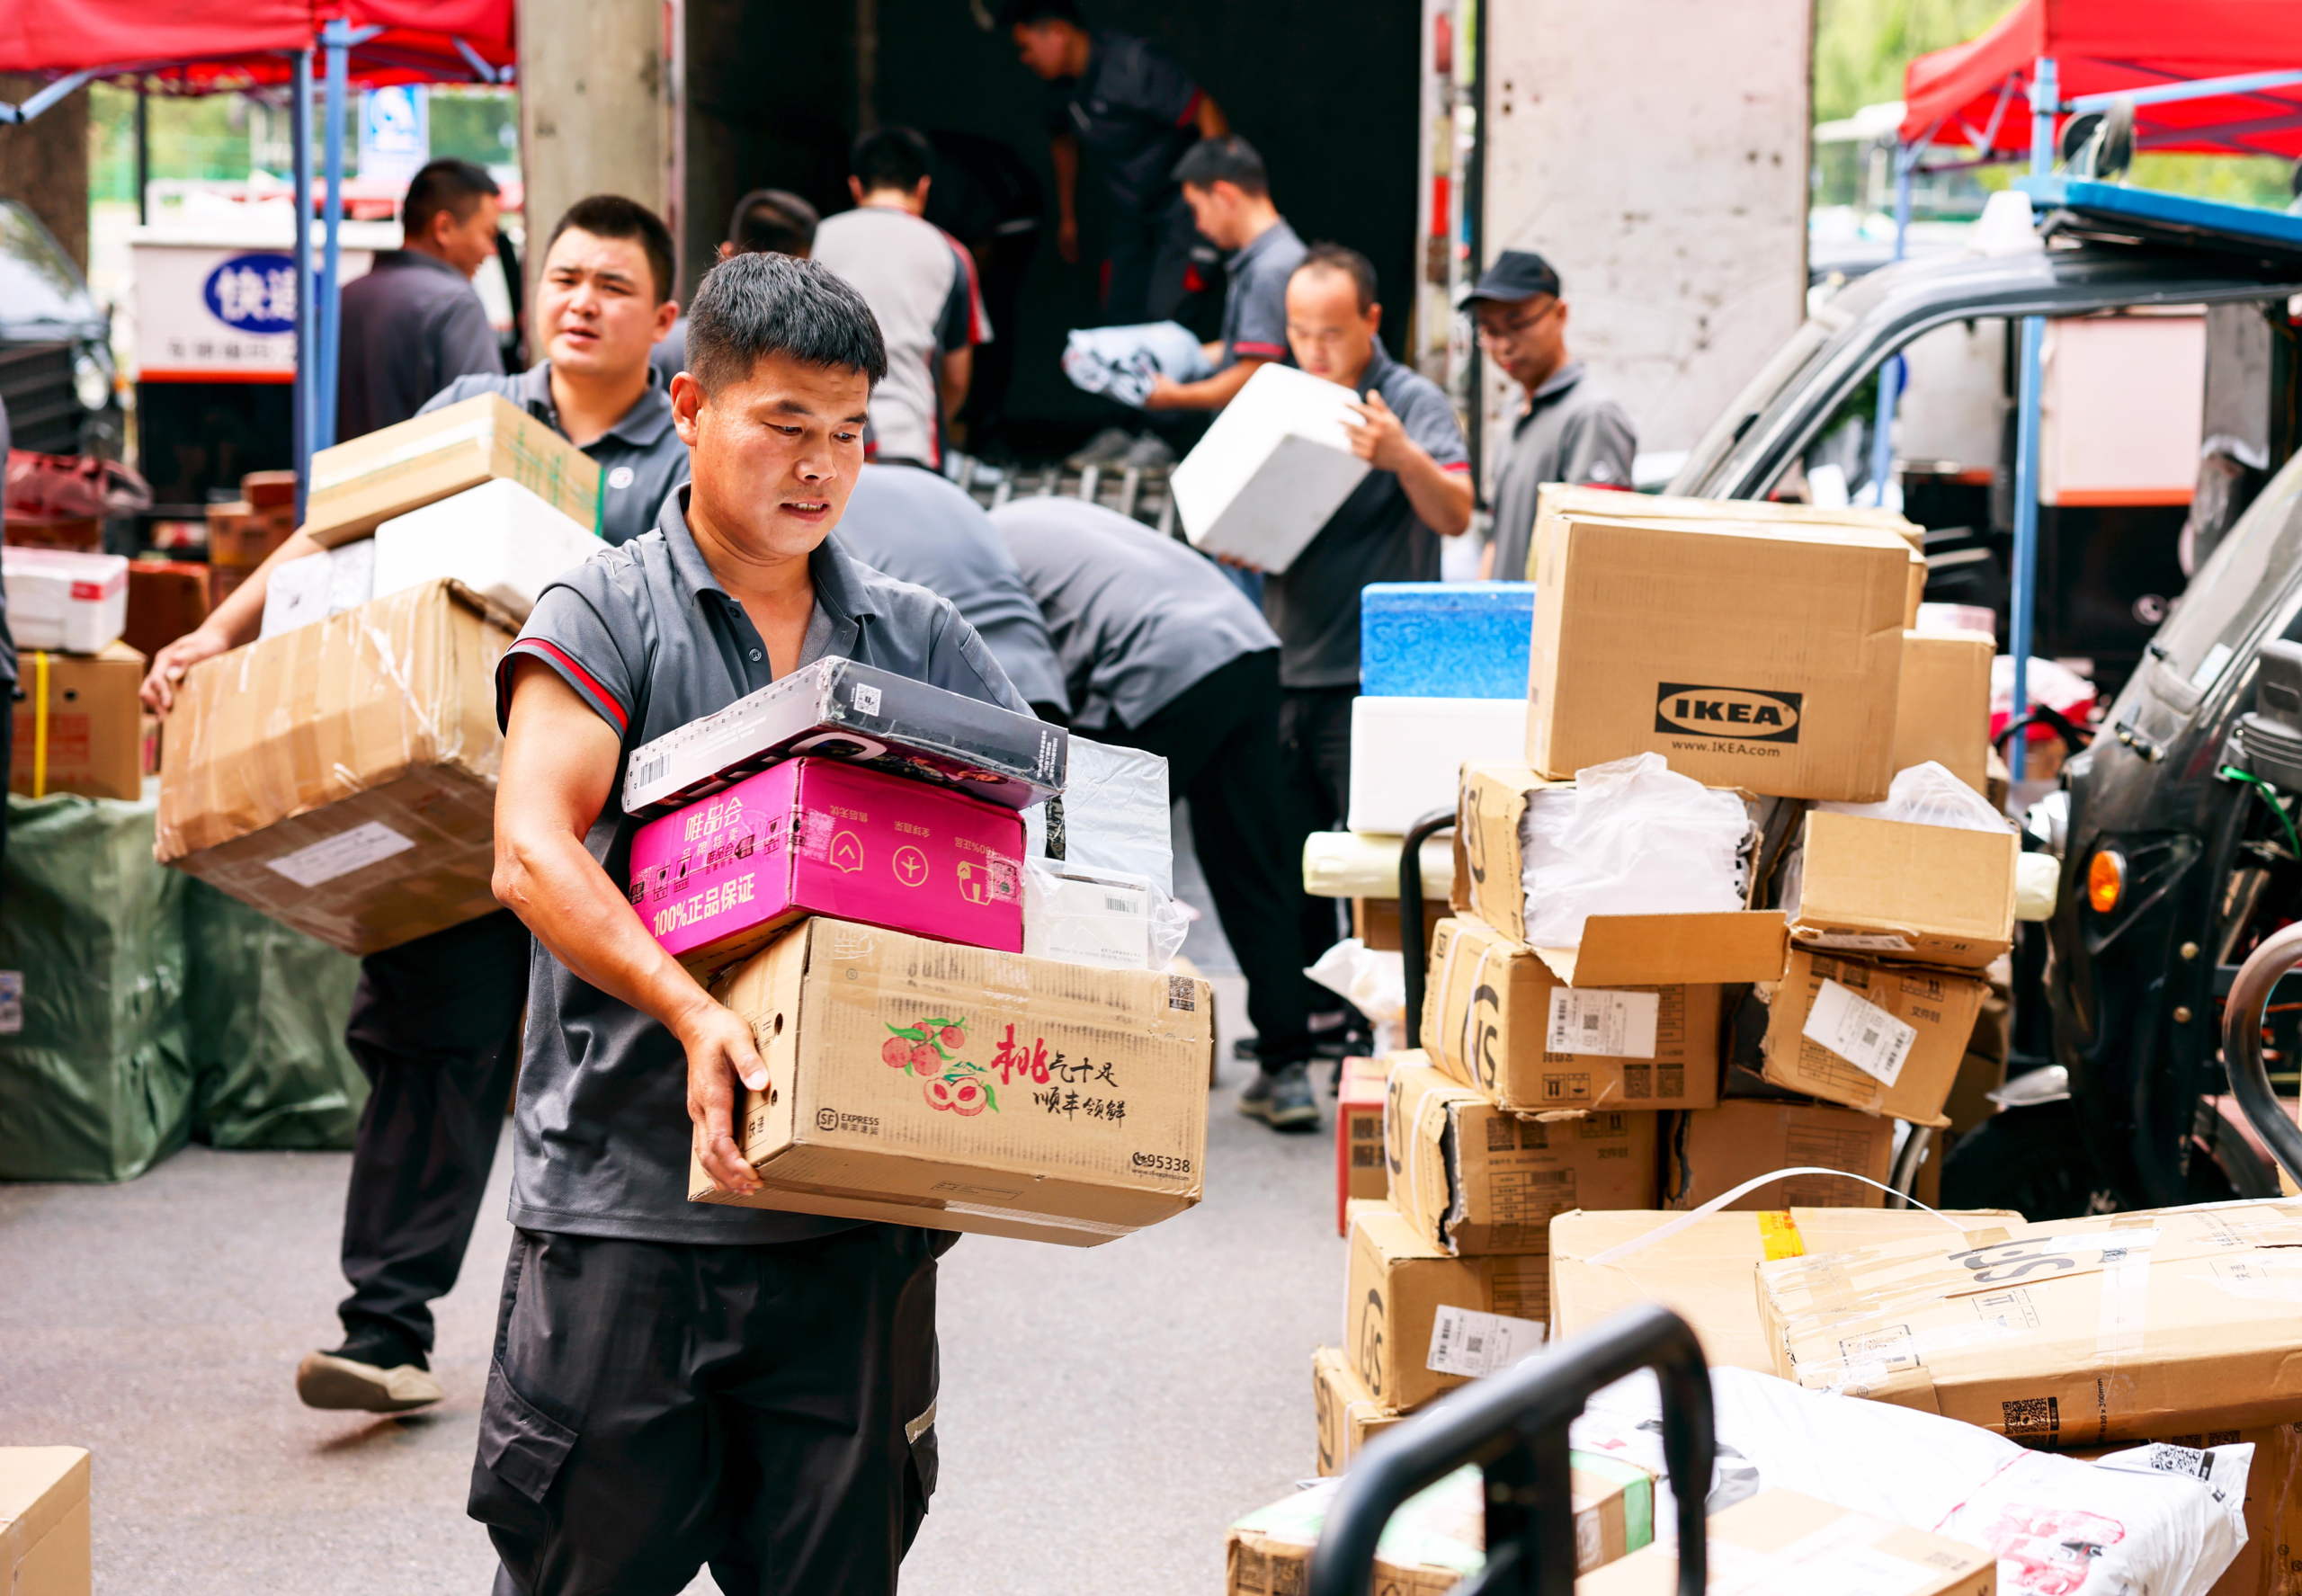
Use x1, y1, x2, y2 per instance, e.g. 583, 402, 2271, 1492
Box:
497, 493, 1029, 1244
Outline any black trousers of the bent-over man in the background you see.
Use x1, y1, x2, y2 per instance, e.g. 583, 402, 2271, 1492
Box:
1098, 649, 1326, 1066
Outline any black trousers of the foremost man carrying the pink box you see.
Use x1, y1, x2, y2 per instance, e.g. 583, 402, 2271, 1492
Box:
469, 1226, 958, 1596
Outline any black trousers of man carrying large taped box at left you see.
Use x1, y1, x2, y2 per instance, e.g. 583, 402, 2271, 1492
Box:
336, 910, 530, 1351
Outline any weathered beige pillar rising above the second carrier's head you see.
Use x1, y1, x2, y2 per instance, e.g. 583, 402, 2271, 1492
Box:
521, 0, 682, 286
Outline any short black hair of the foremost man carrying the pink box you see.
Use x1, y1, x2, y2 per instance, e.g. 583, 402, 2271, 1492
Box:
688, 254, 887, 394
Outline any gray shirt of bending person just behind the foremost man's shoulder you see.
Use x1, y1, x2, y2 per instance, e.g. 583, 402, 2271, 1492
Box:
834, 465, 1070, 717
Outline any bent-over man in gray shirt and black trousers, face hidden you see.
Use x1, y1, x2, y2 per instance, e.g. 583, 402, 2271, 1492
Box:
992, 495, 1319, 1128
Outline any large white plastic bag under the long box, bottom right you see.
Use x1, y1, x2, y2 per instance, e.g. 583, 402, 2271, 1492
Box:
1570, 1368, 2249, 1596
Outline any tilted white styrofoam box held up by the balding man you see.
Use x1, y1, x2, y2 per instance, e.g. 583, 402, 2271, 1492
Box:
1167, 361, 1368, 574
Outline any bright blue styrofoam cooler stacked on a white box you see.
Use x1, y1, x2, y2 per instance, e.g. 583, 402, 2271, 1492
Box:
1358, 583, 1536, 698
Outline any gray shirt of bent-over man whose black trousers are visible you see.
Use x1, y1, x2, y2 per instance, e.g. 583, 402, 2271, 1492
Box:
992, 495, 1280, 730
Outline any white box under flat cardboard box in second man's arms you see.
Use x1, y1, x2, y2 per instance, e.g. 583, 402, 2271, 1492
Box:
375, 477, 605, 617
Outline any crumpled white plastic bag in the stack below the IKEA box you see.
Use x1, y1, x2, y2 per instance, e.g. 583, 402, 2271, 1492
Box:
1520, 753, 1752, 947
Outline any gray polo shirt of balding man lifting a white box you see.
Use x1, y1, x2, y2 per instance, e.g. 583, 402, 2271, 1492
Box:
1263, 343, 1471, 686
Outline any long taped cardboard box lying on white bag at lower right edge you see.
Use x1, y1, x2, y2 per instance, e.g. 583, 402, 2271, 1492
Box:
1759, 1199, 2302, 1447
